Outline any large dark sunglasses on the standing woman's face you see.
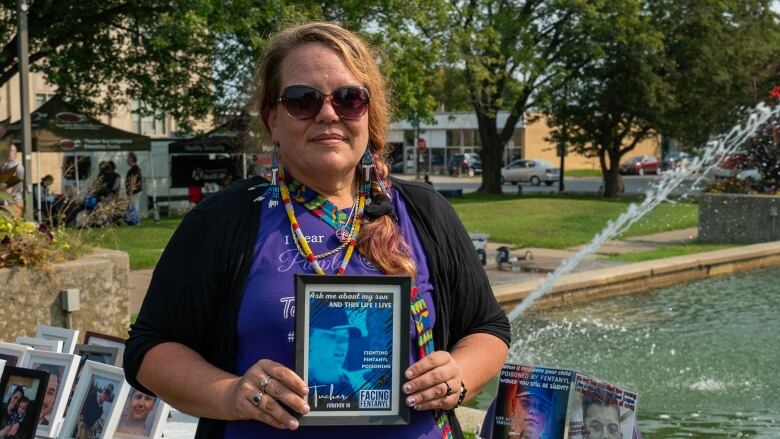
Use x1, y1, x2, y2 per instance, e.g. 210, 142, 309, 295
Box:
277, 85, 371, 120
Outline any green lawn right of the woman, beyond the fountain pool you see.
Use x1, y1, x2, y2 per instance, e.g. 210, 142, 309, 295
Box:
452, 193, 698, 249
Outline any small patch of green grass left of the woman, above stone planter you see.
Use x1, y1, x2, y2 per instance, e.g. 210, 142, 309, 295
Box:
82, 217, 181, 270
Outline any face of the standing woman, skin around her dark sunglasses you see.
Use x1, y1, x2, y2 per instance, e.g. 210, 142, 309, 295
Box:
268, 43, 368, 181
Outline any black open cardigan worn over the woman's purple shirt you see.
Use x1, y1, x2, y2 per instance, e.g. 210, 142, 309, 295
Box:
124, 178, 510, 438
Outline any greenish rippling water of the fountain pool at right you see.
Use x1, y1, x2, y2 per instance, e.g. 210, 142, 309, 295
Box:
478, 269, 780, 438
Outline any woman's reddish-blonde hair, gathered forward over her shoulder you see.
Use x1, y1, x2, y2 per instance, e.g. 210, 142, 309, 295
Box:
249, 21, 416, 277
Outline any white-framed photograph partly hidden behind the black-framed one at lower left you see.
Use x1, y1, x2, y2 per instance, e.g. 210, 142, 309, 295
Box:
25, 351, 79, 438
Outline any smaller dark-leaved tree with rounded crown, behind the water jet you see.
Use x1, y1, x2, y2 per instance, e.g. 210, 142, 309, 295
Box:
549, 0, 670, 196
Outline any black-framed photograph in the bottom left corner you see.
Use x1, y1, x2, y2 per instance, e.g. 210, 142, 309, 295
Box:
0, 366, 49, 439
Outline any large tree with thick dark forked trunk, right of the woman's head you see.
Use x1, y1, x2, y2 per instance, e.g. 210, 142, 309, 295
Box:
380, 0, 582, 193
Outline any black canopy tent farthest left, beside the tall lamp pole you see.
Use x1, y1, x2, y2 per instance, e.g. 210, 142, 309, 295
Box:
0, 95, 156, 220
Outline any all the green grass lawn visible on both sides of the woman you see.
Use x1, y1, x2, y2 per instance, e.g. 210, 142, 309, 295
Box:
82, 193, 698, 270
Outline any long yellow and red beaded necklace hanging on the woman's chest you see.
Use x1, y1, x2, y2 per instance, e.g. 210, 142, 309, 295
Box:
279, 166, 367, 276
